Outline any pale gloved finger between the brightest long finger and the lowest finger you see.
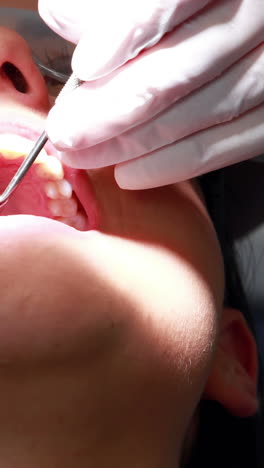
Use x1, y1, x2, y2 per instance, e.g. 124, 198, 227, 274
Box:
56, 44, 264, 169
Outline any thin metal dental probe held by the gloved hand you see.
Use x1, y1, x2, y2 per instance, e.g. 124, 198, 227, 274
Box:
0, 74, 83, 208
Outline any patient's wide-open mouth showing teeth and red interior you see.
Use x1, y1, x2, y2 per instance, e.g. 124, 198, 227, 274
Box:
0, 124, 98, 231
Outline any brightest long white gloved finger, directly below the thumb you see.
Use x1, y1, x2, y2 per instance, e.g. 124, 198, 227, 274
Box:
46, 0, 264, 150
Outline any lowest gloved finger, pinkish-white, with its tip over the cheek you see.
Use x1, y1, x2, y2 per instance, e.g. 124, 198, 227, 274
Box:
115, 104, 264, 190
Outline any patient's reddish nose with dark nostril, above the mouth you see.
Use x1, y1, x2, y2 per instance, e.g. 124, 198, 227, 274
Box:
0, 27, 49, 111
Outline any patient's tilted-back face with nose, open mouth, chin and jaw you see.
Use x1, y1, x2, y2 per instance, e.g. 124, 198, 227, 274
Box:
0, 28, 223, 467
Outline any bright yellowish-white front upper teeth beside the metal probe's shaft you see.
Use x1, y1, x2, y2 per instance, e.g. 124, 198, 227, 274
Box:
0, 133, 48, 163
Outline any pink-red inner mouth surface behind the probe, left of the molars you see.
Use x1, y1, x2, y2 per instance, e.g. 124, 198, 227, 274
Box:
0, 152, 53, 218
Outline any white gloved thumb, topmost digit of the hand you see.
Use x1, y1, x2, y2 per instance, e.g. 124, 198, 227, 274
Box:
72, 0, 212, 81
